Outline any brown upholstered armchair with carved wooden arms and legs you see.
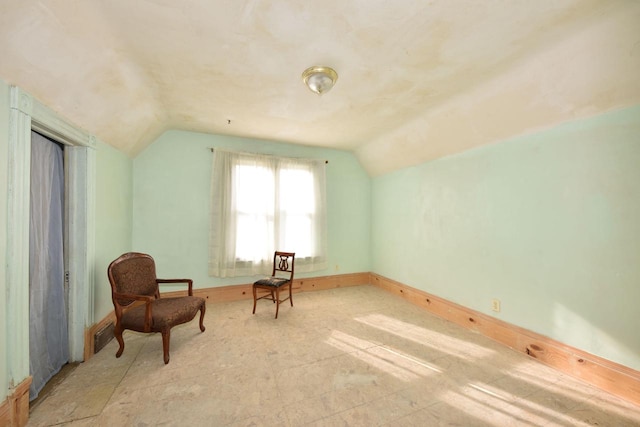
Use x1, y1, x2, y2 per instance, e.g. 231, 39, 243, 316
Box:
107, 252, 206, 364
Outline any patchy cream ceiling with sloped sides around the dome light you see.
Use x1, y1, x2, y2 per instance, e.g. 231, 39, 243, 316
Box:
0, 0, 640, 175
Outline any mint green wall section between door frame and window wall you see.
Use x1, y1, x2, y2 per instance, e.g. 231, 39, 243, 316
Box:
94, 142, 133, 322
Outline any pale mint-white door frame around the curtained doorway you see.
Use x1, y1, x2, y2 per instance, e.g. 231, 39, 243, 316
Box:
7, 86, 96, 384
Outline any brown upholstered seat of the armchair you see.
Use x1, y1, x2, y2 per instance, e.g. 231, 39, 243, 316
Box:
121, 296, 205, 332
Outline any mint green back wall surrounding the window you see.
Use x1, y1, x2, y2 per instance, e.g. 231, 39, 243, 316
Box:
133, 131, 371, 288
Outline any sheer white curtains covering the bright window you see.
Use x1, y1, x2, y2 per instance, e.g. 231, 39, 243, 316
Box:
209, 149, 327, 277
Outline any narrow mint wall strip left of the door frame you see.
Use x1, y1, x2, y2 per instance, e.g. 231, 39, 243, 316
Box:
0, 80, 9, 404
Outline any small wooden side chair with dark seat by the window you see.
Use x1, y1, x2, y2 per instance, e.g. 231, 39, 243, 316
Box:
253, 251, 296, 319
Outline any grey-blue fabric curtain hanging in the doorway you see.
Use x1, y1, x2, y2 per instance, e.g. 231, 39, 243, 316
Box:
29, 132, 69, 400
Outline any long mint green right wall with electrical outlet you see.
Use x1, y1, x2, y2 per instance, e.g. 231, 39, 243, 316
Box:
372, 107, 640, 369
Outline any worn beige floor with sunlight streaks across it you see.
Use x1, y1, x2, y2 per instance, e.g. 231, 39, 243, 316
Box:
28, 286, 640, 427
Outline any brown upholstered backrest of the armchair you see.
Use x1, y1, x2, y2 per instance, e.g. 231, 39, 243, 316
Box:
107, 252, 160, 306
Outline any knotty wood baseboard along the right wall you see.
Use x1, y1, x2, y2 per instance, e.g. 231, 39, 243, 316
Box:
370, 273, 640, 405
